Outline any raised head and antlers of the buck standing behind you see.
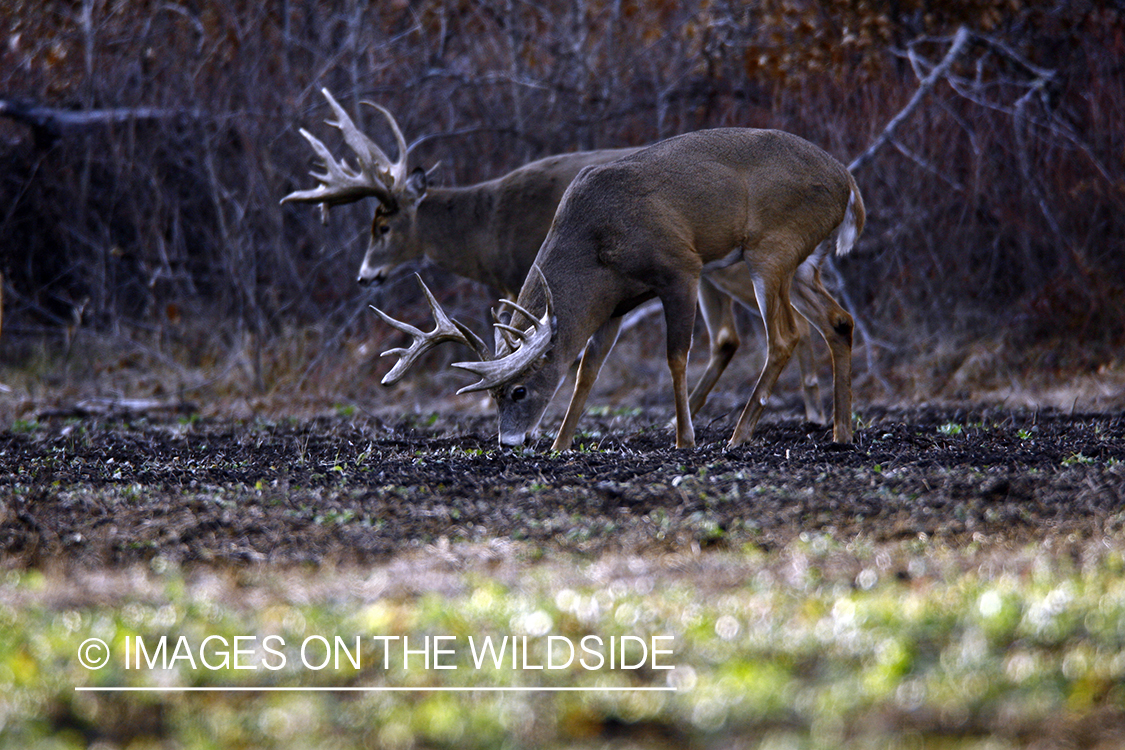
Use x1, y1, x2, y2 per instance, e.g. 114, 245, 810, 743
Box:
281, 89, 428, 284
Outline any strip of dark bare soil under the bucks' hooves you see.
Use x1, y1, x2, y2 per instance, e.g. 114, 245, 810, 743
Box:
0, 408, 1125, 567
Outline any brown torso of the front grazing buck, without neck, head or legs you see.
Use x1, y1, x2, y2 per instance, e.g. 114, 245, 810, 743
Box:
541, 128, 854, 281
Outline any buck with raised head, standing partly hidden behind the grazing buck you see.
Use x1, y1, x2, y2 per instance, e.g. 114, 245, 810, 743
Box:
281, 89, 824, 423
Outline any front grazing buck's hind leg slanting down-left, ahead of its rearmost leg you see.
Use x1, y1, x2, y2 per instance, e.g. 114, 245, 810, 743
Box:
727, 268, 798, 448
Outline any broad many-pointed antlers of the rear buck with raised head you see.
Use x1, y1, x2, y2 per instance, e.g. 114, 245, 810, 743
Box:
281, 89, 406, 207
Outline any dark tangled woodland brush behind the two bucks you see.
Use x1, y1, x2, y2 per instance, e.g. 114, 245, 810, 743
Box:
0, 0, 1125, 411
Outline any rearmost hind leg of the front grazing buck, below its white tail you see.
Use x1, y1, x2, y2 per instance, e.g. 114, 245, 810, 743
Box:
793, 255, 855, 443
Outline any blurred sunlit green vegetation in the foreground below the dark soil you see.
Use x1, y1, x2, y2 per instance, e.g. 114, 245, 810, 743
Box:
0, 535, 1125, 748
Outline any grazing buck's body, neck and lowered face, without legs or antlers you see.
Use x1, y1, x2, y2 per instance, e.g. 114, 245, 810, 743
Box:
479, 128, 862, 443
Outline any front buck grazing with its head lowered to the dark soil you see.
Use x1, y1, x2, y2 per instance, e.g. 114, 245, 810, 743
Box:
379, 128, 865, 450
